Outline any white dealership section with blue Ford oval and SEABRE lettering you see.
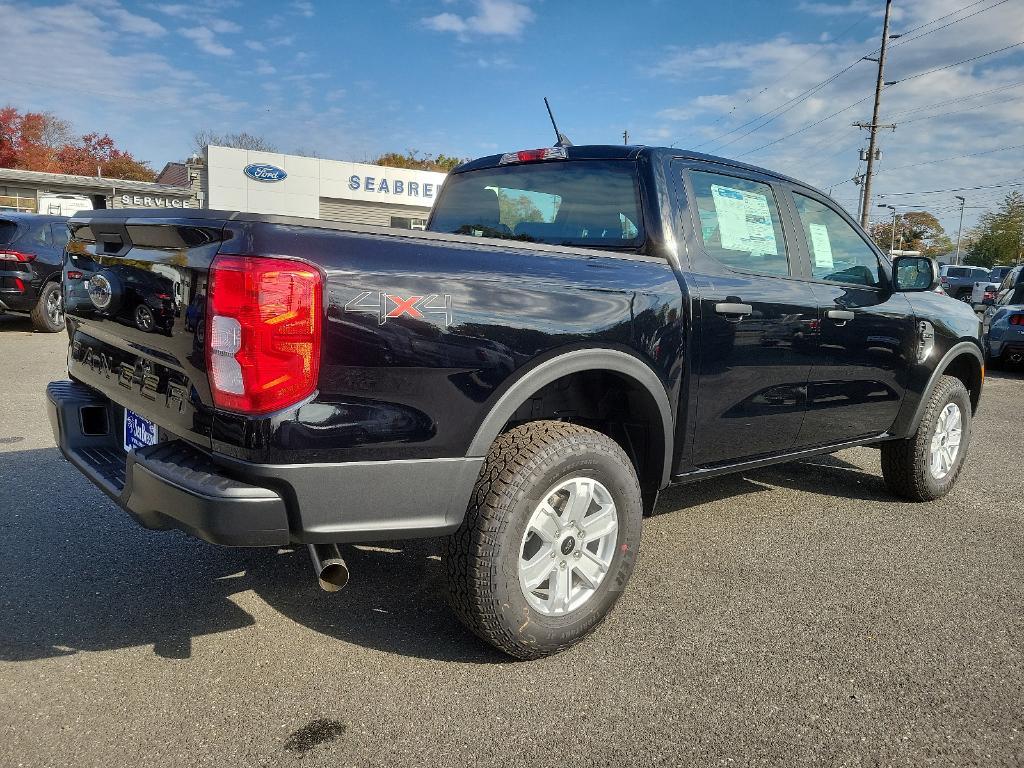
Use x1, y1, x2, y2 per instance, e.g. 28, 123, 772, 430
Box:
157, 146, 444, 229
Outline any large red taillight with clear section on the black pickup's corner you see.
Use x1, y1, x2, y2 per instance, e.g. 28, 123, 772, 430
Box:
206, 256, 323, 414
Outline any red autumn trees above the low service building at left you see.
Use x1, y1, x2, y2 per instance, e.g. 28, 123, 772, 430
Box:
0, 105, 156, 181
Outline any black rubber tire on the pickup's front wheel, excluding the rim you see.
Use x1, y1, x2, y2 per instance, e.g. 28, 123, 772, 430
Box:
882, 376, 971, 502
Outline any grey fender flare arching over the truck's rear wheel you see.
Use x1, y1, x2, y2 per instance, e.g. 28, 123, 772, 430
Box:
466, 349, 675, 487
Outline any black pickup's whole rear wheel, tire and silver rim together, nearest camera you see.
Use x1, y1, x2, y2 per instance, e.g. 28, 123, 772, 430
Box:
445, 421, 643, 658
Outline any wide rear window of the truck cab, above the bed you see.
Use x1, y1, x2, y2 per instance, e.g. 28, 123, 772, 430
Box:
429, 160, 643, 248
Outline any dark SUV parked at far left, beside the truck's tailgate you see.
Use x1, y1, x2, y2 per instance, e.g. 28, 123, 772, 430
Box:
0, 213, 69, 333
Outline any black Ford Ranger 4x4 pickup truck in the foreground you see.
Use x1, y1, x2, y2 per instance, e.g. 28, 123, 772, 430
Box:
47, 145, 984, 658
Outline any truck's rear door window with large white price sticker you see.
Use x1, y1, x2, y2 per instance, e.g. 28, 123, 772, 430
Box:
689, 171, 790, 274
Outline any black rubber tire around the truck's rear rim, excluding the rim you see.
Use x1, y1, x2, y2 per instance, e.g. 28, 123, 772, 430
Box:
445, 421, 643, 658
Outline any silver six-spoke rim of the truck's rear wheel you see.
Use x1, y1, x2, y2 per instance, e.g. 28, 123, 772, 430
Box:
519, 476, 618, 616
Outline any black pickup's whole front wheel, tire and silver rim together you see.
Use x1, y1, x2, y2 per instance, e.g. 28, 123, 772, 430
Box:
882, 376, 971, 502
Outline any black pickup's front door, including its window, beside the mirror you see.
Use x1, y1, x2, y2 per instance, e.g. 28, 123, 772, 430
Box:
778, 188, 918, 447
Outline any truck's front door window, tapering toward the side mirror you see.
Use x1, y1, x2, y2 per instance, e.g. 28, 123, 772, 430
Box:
793, 193, 884, 288
